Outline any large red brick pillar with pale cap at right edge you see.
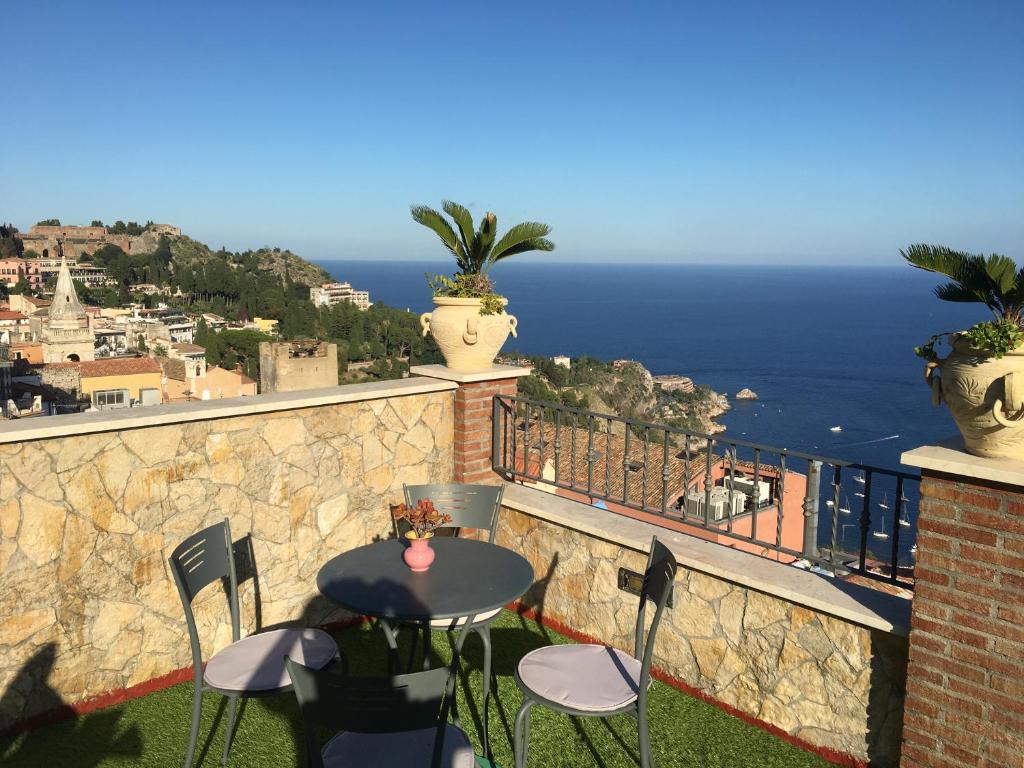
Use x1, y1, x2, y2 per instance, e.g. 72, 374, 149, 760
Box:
900, 446, 1024, 768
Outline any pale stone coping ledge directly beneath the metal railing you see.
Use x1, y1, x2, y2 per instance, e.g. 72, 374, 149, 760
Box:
502, 483, 910, 636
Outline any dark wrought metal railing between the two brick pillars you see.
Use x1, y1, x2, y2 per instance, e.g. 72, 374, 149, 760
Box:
492, 395, 921, 587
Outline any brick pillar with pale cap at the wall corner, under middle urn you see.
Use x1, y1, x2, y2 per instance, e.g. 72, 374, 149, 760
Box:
411, 366, 530, 483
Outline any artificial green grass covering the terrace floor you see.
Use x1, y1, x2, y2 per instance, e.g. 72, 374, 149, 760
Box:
0, 611, 829, 768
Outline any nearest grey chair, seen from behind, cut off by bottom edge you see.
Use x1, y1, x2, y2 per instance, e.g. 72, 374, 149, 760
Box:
287, 656, 476, 768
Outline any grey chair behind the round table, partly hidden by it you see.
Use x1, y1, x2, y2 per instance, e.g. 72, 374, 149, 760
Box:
395, 483, 504, 759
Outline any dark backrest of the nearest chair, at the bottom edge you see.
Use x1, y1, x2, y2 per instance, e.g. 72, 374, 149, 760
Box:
285, 655, 458, 768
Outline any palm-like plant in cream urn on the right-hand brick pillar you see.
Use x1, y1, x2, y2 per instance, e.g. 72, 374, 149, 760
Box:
900, 245, 1024, 459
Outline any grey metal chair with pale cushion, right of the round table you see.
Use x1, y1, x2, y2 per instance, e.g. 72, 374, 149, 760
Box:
512, 537, 678, 768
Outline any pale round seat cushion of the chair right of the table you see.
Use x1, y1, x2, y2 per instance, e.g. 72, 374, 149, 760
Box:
519, 645, 640, 712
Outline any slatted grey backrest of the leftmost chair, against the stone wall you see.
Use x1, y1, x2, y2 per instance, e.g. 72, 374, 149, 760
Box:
168, 517, 240, 680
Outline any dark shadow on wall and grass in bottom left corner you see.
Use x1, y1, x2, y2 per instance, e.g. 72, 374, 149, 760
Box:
0, 643, 142, 768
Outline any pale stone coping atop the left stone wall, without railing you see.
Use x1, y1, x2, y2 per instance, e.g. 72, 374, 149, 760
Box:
0, 378, 459, 443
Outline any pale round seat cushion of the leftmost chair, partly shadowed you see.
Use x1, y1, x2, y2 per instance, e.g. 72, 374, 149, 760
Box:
203, 629, 338, 692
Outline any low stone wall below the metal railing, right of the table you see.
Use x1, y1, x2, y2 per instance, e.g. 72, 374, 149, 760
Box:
498, 501, 907, 766
